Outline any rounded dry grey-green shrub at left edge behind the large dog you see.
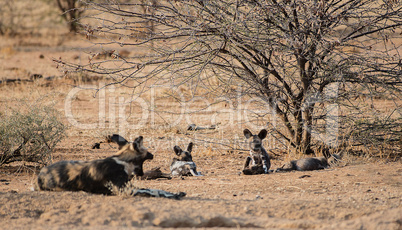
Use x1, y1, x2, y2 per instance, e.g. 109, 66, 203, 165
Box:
0, 98, 66, 166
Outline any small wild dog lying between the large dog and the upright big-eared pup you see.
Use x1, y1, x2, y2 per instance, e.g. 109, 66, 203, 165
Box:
170, 142, 201, 176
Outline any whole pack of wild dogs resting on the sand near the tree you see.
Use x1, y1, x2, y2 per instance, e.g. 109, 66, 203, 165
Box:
36, 129, 338, 199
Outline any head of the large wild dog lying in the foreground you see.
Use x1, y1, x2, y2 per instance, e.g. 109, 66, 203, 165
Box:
116, 136, 154, 176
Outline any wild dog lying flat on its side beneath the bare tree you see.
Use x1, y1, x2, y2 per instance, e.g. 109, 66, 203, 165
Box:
275, 154, 340, 172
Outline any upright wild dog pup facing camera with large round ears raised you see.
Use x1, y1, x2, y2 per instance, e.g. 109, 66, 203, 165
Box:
243, 129, 271, 175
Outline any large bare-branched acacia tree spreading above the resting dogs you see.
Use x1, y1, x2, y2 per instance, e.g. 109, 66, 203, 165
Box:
59, 0, 402, 153
